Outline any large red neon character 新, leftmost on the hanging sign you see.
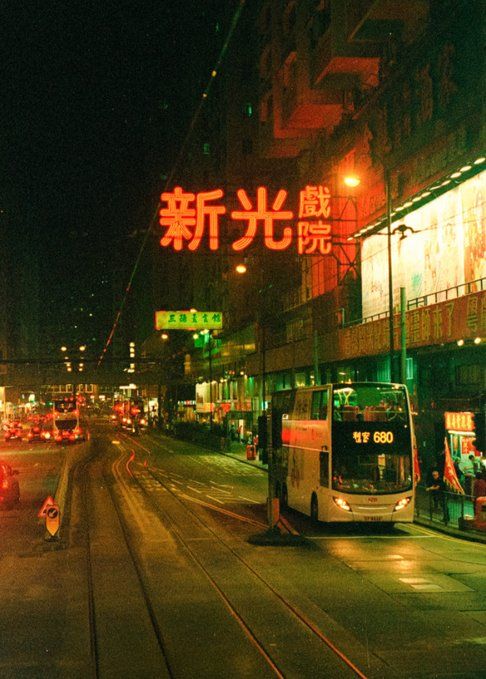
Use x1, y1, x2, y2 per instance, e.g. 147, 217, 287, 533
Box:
159, 186, 226, 251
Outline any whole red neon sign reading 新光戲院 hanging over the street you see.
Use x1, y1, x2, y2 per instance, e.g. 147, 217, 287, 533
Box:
159, 185, 332, 255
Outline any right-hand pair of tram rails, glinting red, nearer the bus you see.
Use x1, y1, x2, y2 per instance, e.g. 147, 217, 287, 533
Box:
119, 432, 367, 679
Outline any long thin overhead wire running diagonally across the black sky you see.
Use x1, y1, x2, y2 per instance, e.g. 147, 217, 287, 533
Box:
96, 0, 246, 368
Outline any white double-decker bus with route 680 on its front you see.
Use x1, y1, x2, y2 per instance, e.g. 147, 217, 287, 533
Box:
269, 382, 415, 523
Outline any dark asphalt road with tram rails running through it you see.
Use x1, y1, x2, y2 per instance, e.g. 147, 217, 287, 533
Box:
0, 425, 486, 678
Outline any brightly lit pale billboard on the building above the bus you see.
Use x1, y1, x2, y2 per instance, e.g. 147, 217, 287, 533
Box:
362, 172, 486, 318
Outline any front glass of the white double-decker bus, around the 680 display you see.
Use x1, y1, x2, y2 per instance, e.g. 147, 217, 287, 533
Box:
332, 383, 412, 494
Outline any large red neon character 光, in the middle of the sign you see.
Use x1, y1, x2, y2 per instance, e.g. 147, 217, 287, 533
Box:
231, 186, 294, 251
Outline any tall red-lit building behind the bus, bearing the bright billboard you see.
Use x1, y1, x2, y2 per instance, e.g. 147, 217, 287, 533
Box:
152, 0, 486, 472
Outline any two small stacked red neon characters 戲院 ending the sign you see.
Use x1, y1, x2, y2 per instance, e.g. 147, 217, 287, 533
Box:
297, 185, 332, 255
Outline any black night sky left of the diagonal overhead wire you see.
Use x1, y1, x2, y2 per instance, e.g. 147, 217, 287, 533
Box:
0, 0, 227, 348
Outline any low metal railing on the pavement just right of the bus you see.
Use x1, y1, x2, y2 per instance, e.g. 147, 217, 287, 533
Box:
415, 486, 474, 529
